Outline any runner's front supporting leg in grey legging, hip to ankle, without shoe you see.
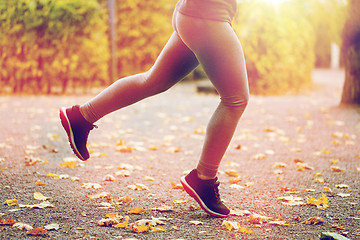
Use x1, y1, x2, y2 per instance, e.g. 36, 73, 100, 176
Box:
176, 13, 249, 179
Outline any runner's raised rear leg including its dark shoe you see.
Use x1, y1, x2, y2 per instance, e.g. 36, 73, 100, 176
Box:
60, 32, 199, 160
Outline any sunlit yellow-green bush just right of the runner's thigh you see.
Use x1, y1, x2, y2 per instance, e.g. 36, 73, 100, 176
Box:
234, 0, 315, 95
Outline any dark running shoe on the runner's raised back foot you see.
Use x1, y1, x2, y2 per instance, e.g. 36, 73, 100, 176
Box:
60, 105, 97, 161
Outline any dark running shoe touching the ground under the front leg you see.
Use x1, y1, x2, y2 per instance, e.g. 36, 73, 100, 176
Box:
180, 169, 230, 217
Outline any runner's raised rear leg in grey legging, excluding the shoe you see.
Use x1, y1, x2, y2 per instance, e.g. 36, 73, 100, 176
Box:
80, 32, 199, 123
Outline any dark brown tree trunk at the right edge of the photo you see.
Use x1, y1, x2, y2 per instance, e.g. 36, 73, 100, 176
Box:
341, 0, 360, 105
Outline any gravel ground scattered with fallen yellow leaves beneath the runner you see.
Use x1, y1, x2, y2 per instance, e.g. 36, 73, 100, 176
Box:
0, 70, 360, 239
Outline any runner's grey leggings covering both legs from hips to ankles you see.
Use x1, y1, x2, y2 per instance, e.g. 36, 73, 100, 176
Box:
80, 11, 249, 179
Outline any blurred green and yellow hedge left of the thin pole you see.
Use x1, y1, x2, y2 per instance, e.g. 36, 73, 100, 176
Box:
0, 0, 109, 93
